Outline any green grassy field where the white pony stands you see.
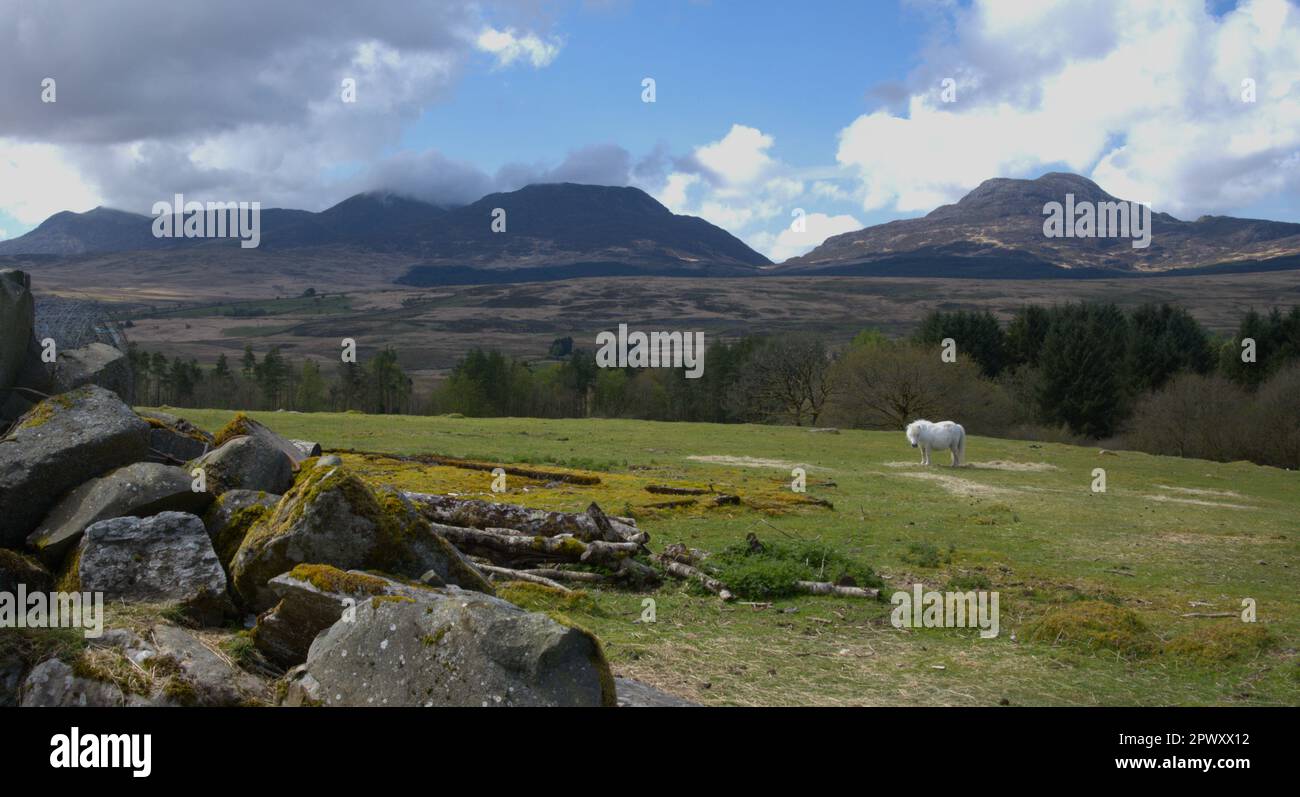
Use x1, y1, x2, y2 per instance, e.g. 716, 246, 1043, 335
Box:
165, 410, 1300, 706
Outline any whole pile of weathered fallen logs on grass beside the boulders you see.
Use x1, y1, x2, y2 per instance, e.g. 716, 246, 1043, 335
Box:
403, 493, 876, 601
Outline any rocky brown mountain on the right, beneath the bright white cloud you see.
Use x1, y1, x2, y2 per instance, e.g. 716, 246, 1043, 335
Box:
775, 172, 1300, 278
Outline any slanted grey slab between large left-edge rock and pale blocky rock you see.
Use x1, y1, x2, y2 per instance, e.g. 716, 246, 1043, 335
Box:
27, 462, 212, 567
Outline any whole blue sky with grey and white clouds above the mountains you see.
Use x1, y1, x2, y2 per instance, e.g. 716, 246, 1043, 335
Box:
0, 0, 1300, 260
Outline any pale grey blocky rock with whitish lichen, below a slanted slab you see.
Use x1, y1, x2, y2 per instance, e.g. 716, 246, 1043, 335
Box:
77, 512, 233, 624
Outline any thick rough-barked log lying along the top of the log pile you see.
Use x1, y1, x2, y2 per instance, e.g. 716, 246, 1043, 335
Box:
403, 493, 639, 543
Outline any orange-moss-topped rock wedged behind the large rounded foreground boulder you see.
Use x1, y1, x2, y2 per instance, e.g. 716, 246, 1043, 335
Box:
252, 564, 441, 667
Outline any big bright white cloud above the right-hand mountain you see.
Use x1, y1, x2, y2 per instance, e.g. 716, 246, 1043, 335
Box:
836, 0, 1300, 216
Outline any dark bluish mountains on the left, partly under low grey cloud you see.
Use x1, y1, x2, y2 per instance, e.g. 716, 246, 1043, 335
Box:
0, 183, 771, 281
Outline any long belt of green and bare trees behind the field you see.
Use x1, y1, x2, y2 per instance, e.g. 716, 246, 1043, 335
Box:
130, 302, 1300, 468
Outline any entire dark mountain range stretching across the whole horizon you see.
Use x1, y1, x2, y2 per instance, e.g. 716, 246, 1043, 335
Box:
0, 173, 1300, 286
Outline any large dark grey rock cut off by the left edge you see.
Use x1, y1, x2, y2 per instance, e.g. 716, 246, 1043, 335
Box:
0, 385, 150, 547
